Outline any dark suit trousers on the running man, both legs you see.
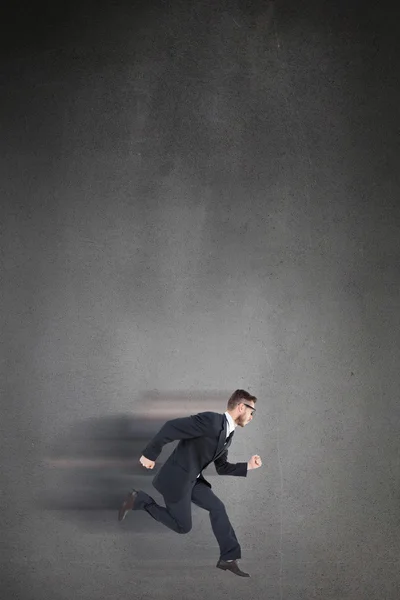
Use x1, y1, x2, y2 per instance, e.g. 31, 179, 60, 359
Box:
133, 480, 241, 560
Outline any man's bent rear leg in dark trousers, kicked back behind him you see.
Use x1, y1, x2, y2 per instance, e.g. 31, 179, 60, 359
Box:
133, 490, 192, 533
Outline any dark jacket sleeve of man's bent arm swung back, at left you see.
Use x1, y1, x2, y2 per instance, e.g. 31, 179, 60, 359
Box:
142, 412, 213, 460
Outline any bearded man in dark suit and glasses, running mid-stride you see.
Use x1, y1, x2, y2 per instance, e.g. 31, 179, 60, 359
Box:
118, 390, 262, 577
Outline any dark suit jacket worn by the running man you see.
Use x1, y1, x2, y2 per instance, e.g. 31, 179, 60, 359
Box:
142, 412, 247, 502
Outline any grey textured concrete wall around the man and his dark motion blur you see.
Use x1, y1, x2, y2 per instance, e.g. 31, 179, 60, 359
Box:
0, 0, 400, 600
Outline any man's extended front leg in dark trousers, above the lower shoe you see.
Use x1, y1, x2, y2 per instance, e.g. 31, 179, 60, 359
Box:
192, 481, 242, 560
